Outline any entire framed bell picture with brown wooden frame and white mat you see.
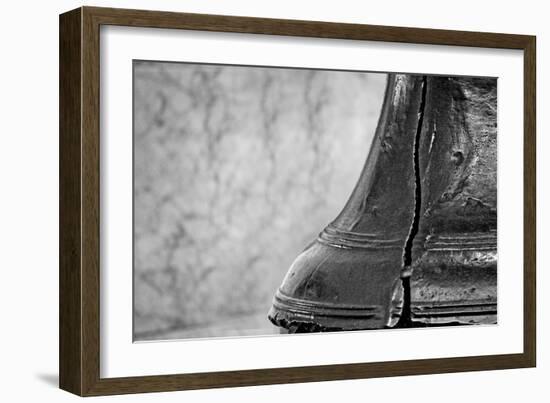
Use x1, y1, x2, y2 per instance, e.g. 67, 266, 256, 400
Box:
60, 7, 536, 396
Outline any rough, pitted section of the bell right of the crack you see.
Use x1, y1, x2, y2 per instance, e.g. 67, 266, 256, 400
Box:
410, 77, 497, 324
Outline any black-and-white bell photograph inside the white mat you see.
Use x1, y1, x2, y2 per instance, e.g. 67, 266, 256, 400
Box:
133, 60, 497, 341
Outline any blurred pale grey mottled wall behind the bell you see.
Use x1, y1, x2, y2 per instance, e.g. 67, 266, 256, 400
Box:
134, 62, 386, 340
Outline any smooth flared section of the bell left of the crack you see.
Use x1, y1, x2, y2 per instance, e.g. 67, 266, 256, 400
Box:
269, 75, 425, 332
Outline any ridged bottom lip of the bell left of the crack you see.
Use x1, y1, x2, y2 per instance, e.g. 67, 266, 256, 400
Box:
268, 289, 389, 331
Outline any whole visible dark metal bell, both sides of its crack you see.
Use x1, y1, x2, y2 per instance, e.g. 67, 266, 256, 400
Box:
268, 74, 496, 333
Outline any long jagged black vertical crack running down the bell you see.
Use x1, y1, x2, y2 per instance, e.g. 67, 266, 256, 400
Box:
396, 76, 428, 327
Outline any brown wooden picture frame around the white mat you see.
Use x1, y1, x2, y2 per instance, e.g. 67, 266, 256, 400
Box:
59, 7, 536, 396
